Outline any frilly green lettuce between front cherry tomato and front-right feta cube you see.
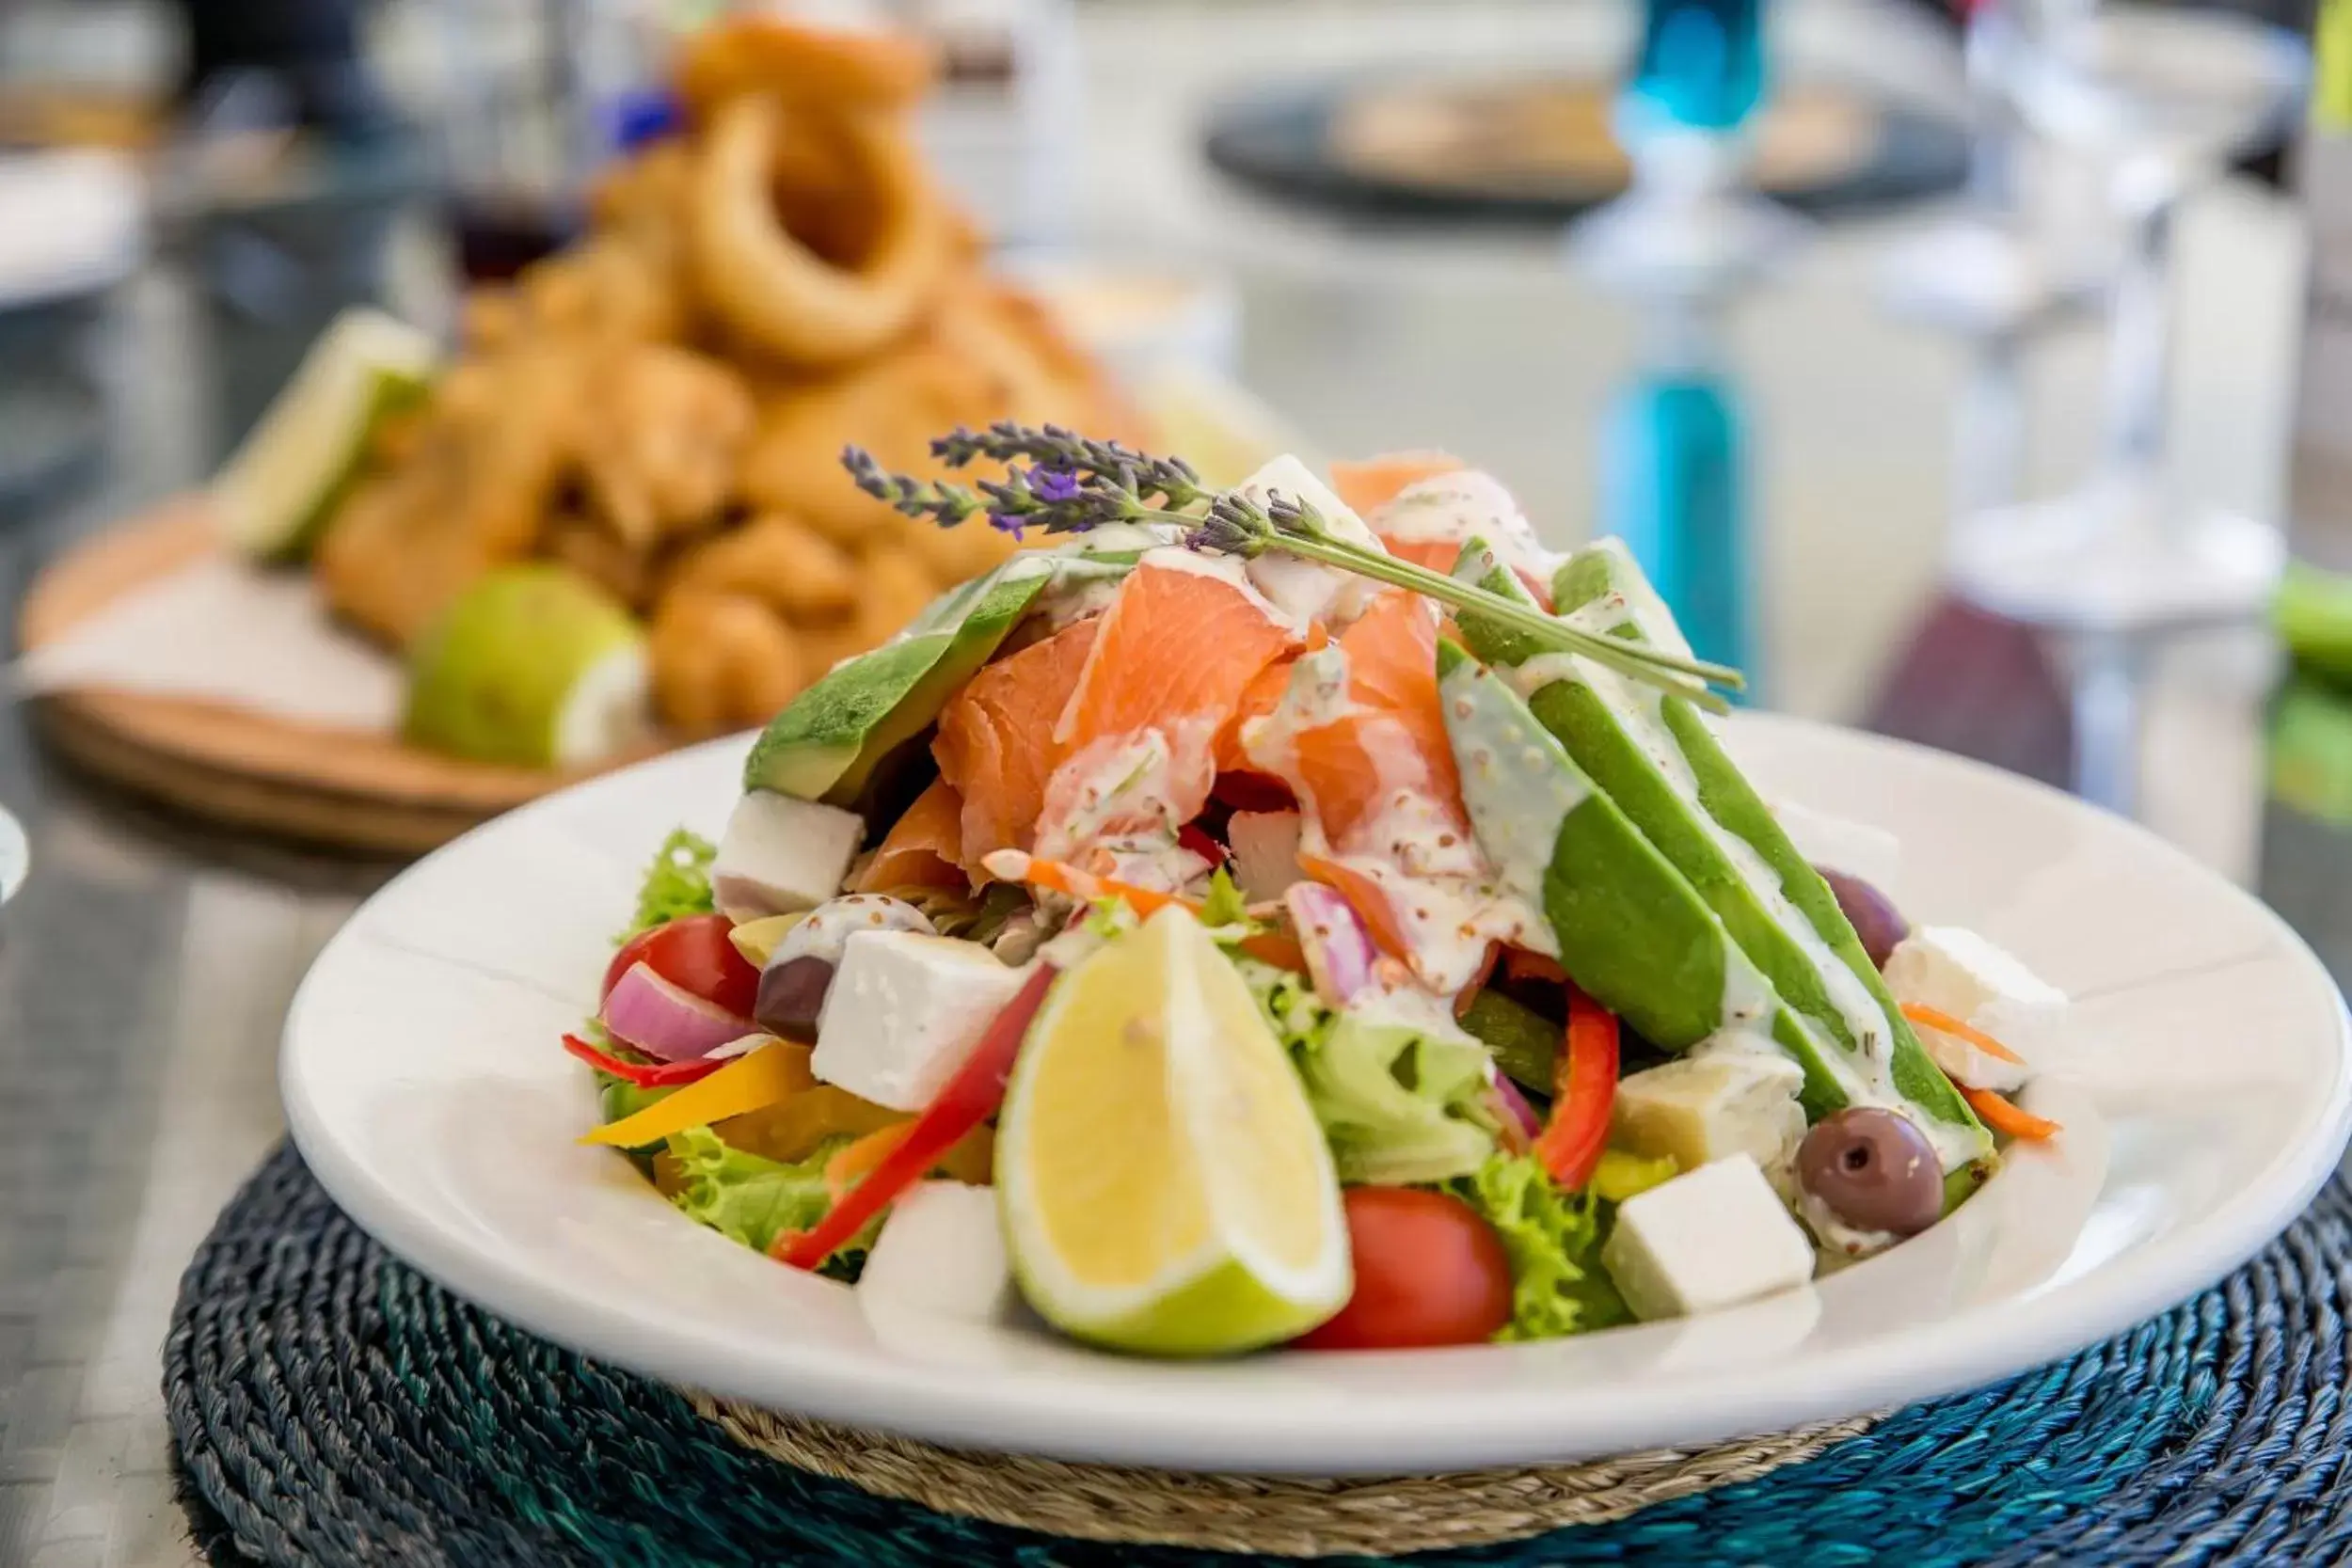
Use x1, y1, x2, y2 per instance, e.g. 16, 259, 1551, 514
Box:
1447, 1154, 1632, 1340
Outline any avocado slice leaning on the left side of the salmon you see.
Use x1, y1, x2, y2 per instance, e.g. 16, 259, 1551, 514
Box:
743, 543, 1143, 806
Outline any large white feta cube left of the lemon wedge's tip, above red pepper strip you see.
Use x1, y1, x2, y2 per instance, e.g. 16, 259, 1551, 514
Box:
809, 931, 1028, 1110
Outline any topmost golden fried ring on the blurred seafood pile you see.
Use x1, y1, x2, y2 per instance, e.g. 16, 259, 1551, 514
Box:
675, 16, 939, 122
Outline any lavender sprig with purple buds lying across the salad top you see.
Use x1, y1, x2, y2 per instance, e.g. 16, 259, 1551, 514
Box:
842, 420, 1743, 712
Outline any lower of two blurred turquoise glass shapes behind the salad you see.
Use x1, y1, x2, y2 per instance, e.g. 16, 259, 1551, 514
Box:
1599, 306, 1762, 701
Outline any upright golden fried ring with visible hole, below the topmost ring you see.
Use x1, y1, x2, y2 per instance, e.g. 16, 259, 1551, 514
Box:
687, 96, 955, 367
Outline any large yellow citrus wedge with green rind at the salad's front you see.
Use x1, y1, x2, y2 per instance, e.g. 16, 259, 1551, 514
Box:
997, 905, 1353, 1356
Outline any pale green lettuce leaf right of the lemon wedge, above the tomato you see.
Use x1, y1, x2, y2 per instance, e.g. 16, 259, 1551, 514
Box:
1240, 961, 1501, 1185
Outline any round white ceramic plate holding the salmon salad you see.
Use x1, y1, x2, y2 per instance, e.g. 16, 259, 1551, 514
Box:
282, 717, 2352, 1474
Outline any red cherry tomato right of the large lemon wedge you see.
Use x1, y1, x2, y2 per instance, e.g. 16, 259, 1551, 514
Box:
1296, 1187, 1510, 1350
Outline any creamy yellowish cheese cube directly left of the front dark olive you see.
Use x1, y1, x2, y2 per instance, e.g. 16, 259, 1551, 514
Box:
1609, 1046, 1804, 1171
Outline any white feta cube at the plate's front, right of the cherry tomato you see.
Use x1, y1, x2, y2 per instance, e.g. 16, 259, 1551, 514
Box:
1602, 1154, 1814, 1319
